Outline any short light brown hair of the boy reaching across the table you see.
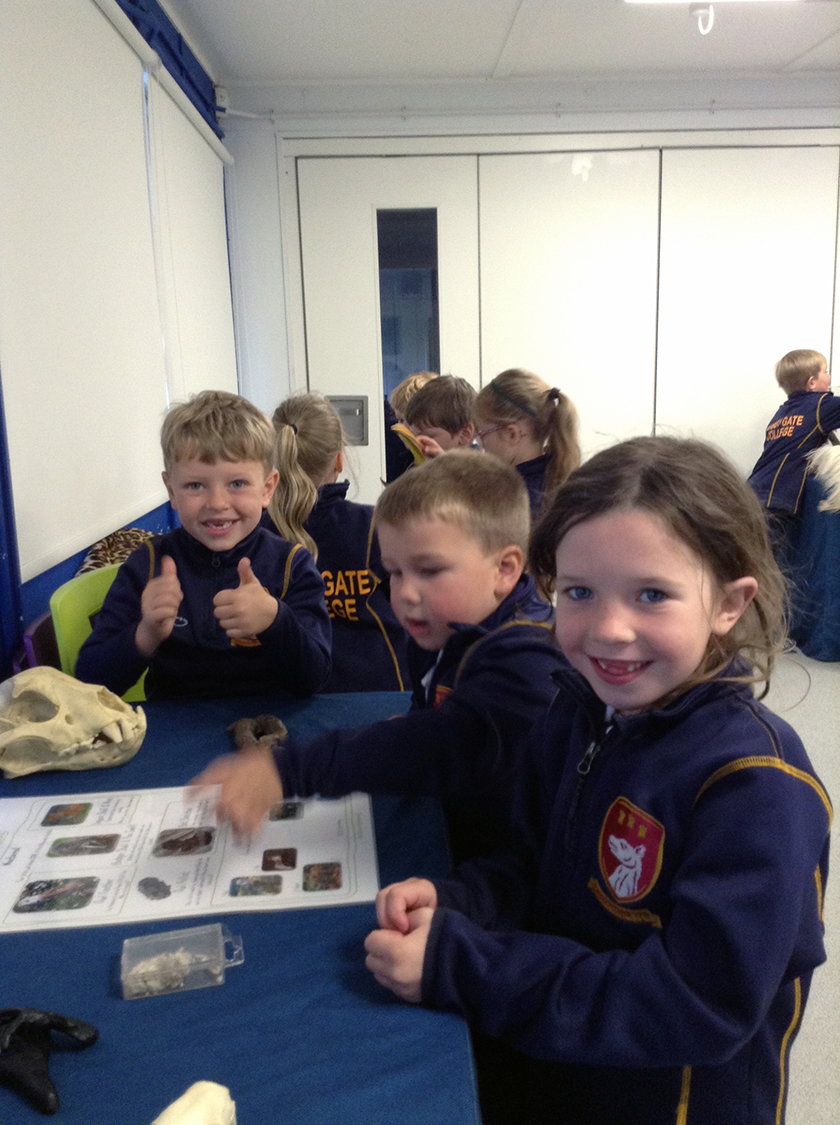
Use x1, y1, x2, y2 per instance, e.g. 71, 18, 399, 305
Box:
373, 449, 531, 555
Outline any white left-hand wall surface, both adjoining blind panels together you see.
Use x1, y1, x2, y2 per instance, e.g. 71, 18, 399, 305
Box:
0, 0, 236, 581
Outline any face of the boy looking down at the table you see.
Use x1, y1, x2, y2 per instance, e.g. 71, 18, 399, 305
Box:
378, 519, 522, 651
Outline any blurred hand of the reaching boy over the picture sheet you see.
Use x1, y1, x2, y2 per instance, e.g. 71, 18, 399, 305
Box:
189, 748, 283, 836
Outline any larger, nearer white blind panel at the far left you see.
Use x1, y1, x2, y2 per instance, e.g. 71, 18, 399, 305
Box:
0, 0, 166, 579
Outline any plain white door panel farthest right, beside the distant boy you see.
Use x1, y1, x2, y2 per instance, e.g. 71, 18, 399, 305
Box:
657, 147, 838, 474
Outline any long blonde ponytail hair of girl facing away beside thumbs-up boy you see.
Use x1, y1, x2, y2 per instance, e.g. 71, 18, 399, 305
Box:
269, 395, 346, 559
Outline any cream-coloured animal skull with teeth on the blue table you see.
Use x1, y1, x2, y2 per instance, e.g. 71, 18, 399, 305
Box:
0, 665, 146, 777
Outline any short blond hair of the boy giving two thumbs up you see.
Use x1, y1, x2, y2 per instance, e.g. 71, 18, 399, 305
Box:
161, 390, 274, 476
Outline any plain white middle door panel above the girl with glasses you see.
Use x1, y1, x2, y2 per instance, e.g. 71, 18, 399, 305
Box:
479, 150, 659, 457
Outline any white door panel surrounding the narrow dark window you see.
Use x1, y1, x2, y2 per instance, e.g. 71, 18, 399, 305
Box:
298, 156, 479, 503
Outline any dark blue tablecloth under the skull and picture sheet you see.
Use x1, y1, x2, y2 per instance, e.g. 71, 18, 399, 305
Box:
0, 693, 479, 1125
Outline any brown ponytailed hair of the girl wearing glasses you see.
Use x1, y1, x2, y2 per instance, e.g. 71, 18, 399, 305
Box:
476, 367, 580, 495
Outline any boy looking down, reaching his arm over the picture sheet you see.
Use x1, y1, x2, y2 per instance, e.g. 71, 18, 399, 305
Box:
193, 450, 564, 855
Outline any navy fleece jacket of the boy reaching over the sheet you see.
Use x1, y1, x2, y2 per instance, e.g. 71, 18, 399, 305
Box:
276, 575, 566, 855
